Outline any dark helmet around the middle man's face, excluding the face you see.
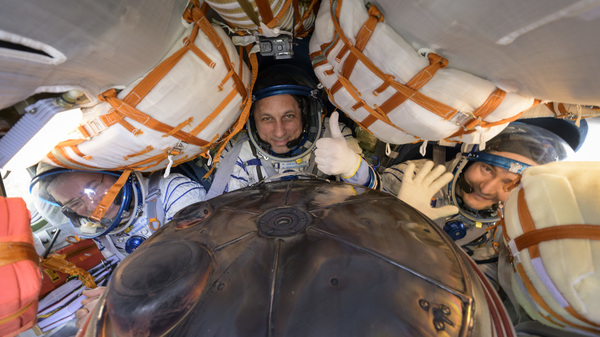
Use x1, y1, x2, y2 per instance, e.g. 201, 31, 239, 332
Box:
246, 64, 323, 163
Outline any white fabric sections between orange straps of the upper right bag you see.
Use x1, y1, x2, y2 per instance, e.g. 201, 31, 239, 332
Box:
309, 0, 534, 144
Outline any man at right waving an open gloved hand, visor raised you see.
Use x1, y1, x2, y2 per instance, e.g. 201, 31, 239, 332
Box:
381, 122, 573, 281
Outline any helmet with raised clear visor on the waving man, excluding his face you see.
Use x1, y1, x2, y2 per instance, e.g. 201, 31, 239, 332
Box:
445, 122, 573, 223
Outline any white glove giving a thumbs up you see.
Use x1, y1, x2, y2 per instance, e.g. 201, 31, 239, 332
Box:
315, 111, 361, 178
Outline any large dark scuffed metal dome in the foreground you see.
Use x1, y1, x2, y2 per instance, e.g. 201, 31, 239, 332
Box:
79, 180, 512, 336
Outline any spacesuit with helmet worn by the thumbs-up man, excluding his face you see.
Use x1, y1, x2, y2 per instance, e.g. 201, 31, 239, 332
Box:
208, 65, 378, 198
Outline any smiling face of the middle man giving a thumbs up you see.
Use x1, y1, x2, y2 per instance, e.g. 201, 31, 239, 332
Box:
254, 95, 302, 153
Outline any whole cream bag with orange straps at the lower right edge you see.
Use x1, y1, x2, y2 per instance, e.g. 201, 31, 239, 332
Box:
503, 162, 600, 335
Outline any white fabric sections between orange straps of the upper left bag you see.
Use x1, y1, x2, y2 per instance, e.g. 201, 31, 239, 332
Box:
47, 26, 251, 171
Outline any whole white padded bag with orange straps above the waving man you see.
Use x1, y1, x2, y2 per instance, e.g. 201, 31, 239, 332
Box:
310, 0, 536, 144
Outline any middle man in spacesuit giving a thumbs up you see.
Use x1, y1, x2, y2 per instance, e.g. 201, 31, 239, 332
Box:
207, 64, 379, 198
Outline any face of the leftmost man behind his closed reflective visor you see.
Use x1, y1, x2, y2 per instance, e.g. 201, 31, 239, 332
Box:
48, 172, 119, 218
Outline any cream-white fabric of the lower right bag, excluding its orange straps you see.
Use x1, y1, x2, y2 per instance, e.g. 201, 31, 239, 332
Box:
504, 162, 600, 332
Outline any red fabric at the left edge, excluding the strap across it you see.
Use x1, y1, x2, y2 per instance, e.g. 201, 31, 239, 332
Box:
0, 197, 41, 336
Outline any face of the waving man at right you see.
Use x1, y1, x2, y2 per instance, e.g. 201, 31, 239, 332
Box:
457, 151, 536, 210
